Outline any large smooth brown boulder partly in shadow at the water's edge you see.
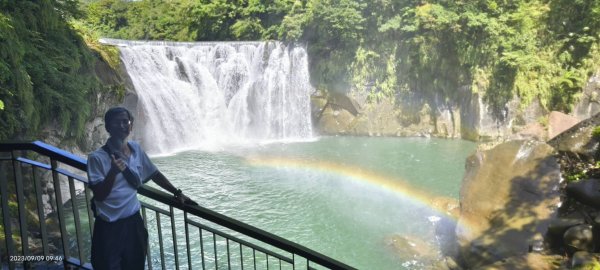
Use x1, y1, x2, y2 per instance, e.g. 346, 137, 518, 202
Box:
456, 141, 560, 268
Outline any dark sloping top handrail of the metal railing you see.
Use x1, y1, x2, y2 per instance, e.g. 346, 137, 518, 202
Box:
0, 141, 355, 269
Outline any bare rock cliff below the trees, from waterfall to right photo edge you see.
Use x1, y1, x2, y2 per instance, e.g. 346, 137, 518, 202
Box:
312, 71, 600, 141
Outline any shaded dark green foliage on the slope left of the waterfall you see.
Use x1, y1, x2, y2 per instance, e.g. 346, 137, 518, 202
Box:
0, 0, 101, 140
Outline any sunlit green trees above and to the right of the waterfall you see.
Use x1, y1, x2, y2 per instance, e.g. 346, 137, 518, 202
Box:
79, 0, 600, 119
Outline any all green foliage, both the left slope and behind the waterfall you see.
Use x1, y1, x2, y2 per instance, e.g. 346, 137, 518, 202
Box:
0, 0, 600, 139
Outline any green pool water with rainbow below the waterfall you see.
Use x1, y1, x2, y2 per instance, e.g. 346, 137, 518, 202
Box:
143, 137, 475, 269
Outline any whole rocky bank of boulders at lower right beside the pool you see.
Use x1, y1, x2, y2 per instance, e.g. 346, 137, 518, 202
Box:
456, 114, 600, 269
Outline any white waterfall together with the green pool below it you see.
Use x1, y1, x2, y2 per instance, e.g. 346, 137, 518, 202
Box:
103, 40, 475, 269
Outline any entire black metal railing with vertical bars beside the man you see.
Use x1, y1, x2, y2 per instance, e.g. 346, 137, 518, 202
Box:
0, 141, 354, 269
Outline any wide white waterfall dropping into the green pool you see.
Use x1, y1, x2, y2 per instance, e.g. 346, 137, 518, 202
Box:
102, 39, 314, 154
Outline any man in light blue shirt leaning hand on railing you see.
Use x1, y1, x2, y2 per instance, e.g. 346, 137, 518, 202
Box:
87, 107, 196, 270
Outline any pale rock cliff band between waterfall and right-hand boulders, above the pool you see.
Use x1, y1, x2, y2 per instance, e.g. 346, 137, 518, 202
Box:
313, 86, 541, 141
